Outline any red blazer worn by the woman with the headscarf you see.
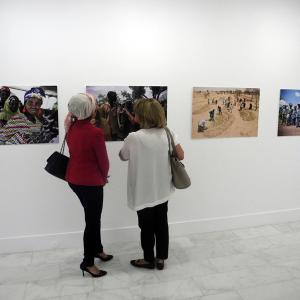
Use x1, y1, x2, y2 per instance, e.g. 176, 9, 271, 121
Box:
66, 119, 109, 186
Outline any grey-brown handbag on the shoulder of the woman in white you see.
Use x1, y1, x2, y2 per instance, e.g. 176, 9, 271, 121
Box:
165, 127, 191, 189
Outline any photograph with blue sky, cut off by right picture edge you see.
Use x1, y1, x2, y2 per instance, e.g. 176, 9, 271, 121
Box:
278, 90, 300, 136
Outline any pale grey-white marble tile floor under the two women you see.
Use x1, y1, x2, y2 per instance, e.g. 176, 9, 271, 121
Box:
0, 221, 300, 300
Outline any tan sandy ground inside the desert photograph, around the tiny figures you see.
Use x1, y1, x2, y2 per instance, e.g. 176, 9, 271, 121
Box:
192, 91, 259, 138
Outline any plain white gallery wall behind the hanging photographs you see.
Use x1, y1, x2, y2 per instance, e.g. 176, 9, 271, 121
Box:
0, 0, 300, 252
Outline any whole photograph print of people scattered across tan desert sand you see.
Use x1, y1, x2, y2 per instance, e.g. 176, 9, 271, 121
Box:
192, 87, 259, 139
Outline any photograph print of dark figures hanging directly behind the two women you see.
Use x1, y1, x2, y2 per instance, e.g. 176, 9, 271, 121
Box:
86, 86, 167, 141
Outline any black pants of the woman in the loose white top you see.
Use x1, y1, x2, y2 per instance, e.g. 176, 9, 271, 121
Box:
137, 202, 169, 262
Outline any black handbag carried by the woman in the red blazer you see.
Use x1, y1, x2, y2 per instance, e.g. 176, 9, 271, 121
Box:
45, 134, 70, 180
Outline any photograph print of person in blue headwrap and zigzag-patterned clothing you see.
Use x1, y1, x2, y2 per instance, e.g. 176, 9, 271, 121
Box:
0, 86, 58, 145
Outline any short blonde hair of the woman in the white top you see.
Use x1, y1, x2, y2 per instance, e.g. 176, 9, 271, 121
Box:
133, 99, 167, 129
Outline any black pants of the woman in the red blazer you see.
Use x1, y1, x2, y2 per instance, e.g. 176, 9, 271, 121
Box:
69, 183, 103, 267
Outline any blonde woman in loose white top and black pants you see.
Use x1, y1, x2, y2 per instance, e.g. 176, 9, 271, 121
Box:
119, 99, 184, 270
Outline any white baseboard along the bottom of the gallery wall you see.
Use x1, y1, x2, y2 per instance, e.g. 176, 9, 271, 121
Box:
0, 208, 300, 253
